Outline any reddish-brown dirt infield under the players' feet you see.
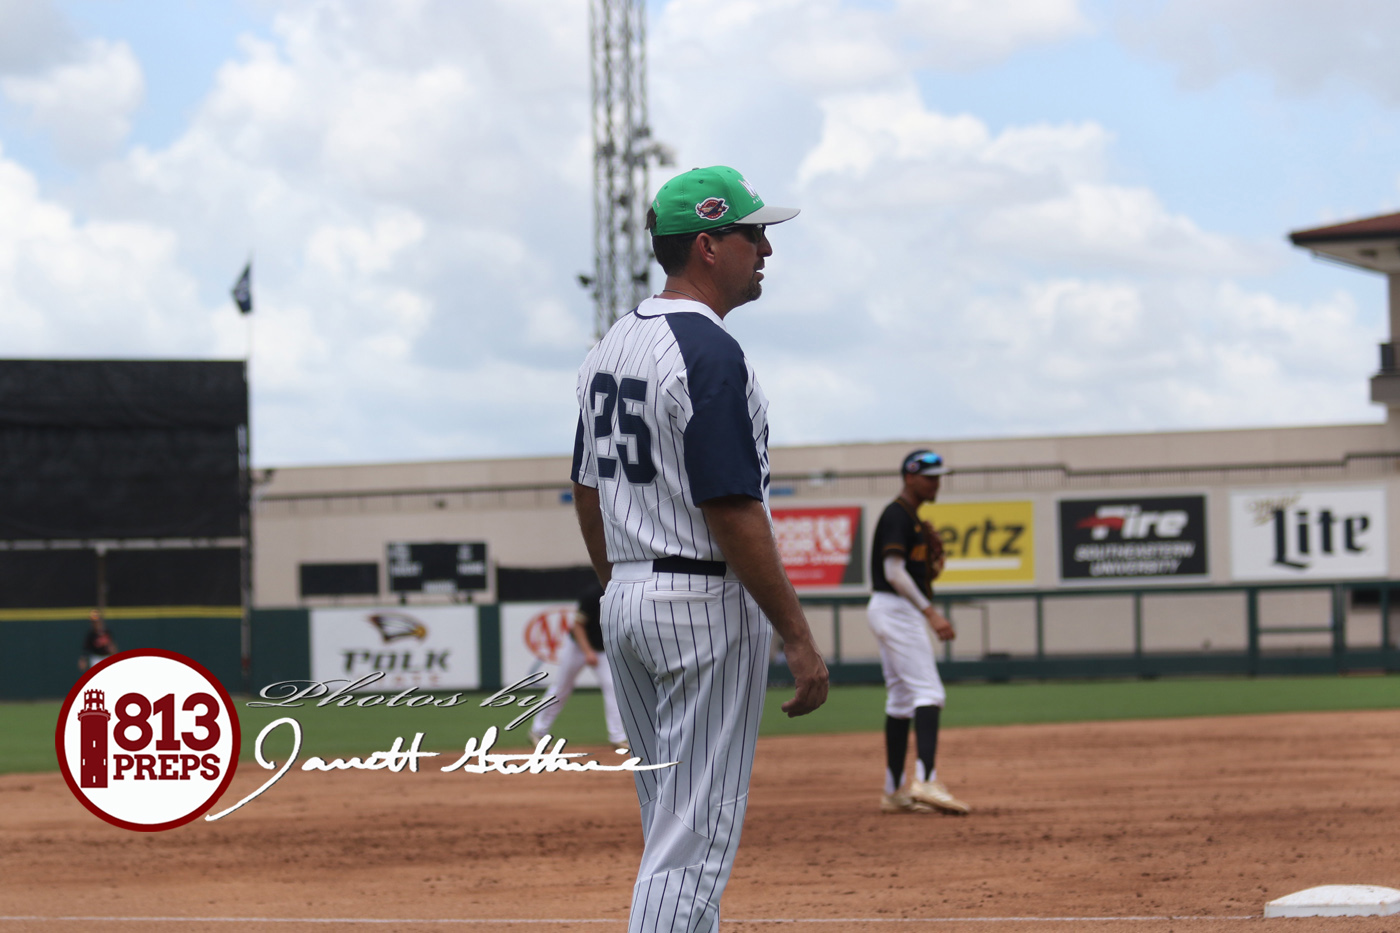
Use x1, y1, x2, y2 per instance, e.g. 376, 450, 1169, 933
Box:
0, 712, 1400, 933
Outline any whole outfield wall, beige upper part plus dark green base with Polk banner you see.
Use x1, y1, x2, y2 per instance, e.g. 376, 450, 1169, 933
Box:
10, 423, 1400, 698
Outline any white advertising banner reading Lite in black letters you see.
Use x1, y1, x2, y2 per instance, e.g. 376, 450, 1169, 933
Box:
1229, 486, 1387, 580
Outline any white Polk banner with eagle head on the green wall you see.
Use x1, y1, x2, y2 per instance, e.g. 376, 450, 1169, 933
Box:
311, 605, 482, 693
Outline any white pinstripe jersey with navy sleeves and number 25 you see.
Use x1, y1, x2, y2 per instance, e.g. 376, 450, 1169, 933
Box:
571, 298, 769, 551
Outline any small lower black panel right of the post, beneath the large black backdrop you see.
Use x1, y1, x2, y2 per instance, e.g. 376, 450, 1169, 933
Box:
106, 548, 242, 607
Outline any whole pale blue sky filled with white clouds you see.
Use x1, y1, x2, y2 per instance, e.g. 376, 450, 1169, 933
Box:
0, 0, 1400, 465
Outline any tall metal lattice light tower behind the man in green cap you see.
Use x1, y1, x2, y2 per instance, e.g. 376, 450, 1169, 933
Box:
578, 0, 673, 338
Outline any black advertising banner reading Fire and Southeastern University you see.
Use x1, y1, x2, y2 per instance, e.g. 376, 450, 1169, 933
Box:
1060, 496, 1210, 583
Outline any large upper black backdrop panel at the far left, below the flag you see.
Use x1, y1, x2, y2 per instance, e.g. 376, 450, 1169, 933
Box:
0, 360, 248, 539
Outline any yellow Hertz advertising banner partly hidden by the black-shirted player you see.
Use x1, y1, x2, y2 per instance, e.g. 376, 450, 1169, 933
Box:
918, 500, 1036, 587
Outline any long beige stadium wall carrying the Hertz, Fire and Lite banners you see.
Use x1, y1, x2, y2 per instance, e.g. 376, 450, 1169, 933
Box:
243, 423, 1400, 689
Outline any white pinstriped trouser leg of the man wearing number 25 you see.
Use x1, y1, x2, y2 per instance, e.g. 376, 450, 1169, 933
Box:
630, 579, 771, 933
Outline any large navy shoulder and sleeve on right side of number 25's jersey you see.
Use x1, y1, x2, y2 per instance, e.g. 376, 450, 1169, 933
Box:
666, 312, 763, 504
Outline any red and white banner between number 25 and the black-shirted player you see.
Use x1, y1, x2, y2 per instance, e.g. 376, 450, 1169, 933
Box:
773, 506, 865, 590
